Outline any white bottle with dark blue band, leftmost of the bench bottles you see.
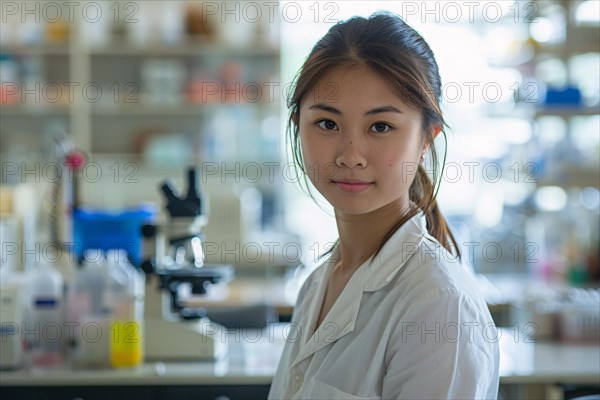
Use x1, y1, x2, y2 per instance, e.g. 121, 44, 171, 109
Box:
25, 262, 65, 368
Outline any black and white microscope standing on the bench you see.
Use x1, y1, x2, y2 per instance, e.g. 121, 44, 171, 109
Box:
142, 168, 234, 361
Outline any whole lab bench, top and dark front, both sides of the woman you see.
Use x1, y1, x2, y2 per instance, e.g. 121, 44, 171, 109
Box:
0, 323, 600, 400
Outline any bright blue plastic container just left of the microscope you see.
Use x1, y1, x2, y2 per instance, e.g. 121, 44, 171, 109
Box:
73, 206, 157, 266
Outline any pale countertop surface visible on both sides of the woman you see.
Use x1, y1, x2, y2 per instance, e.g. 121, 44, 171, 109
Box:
0, 323, 600, 386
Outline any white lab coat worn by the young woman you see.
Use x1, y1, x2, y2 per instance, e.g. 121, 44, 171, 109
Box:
269, 214, 499, 400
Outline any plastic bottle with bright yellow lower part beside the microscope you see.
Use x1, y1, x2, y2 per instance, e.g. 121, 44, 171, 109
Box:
105, 250, 144, 368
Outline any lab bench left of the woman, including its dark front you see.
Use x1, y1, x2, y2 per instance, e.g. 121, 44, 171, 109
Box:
0, 324, 287, 400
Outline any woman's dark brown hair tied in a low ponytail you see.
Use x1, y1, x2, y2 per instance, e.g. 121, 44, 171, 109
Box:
287, 11, 461, 259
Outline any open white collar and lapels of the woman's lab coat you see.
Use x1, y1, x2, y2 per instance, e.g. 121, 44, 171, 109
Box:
292, 213, 427, 367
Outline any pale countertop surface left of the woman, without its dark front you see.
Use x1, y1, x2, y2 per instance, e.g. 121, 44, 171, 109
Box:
0, 323, 289, 386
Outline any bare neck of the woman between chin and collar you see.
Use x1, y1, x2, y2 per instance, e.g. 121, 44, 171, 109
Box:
335, 199, 408, 275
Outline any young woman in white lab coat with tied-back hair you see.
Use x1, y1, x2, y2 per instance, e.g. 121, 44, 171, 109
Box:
269, 12, 499, 399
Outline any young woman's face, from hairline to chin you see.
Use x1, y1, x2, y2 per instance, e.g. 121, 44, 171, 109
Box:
298, 66, 424, 214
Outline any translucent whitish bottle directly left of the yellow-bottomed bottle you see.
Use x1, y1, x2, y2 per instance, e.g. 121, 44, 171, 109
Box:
68, 249, 110, 368
